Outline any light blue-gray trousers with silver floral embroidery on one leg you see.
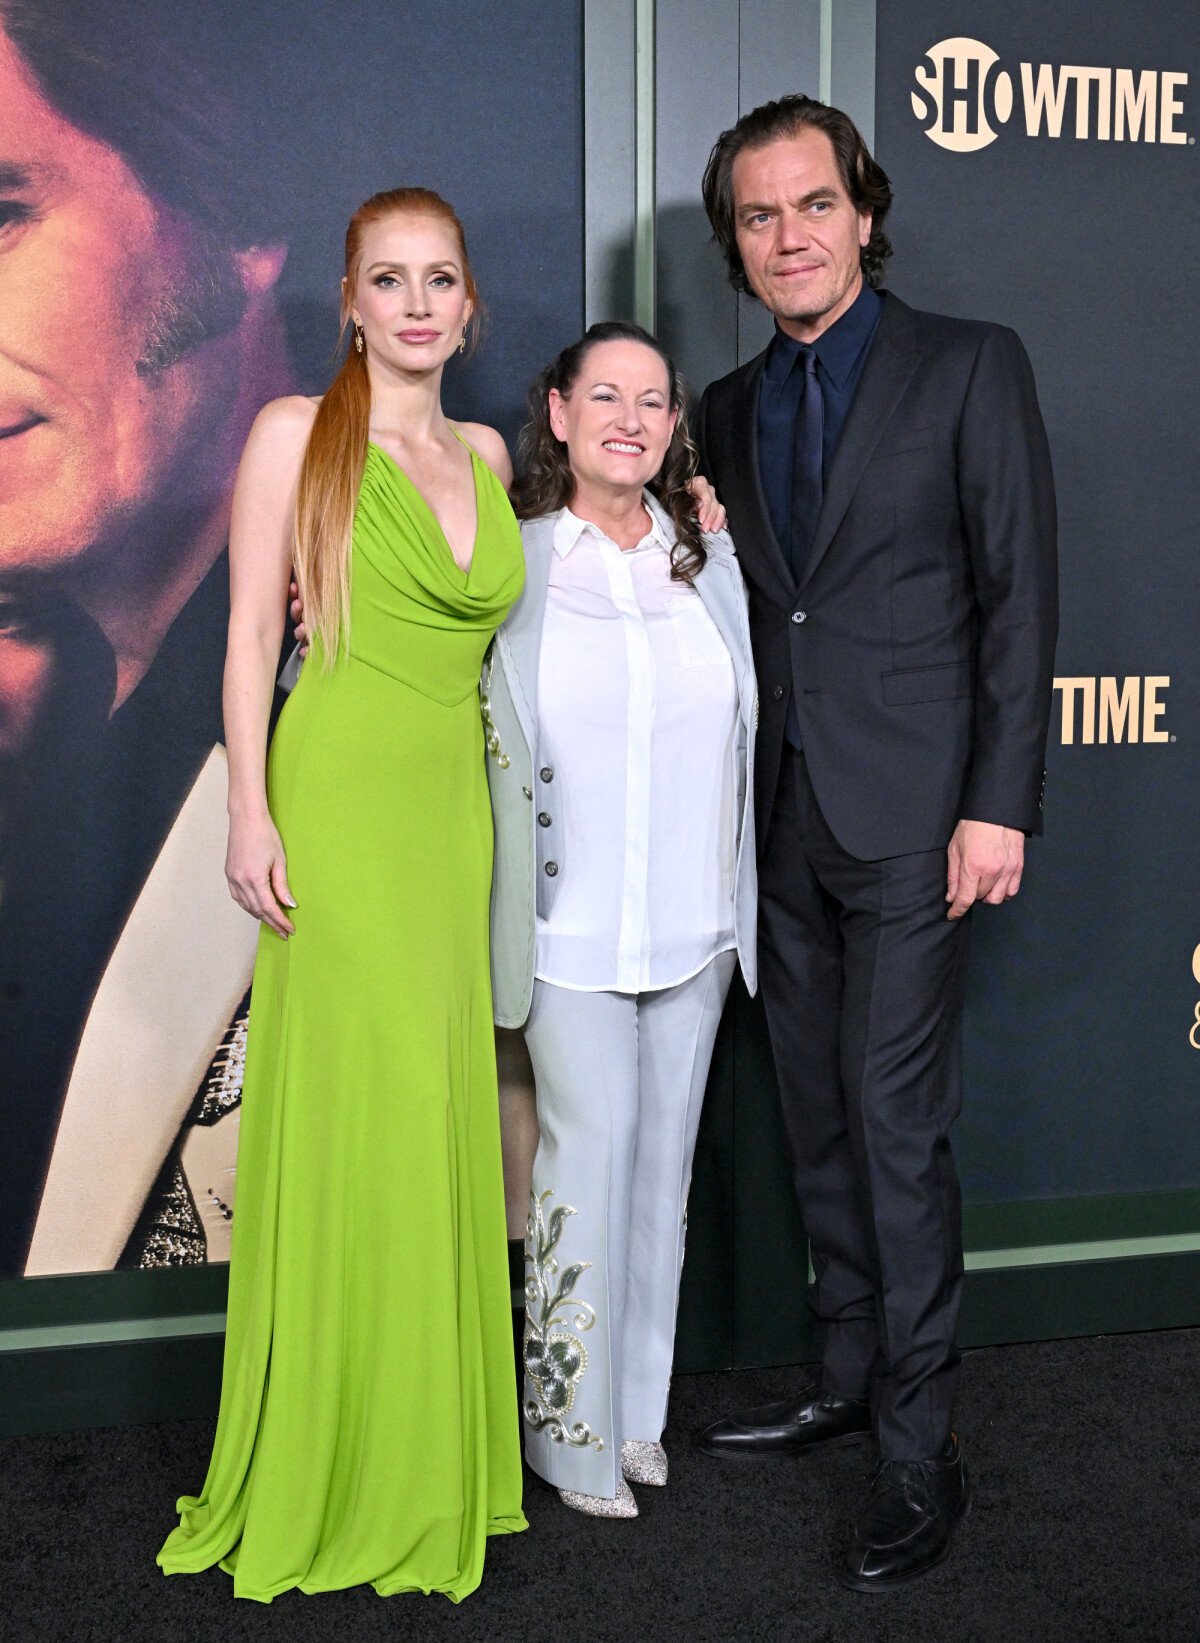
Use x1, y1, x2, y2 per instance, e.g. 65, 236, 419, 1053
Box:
521, 951, 736, 1495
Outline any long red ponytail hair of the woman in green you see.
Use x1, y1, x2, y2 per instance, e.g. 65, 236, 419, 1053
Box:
293, 189, 480, 667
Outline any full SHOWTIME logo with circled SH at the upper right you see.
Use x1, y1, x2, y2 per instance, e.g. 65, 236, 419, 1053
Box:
912, 35, 1192, 154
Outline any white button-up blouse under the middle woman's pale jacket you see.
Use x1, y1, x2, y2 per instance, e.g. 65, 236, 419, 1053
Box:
536, 508, 738, 992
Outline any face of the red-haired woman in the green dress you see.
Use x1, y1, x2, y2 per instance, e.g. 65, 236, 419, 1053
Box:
344, 212, 472, 373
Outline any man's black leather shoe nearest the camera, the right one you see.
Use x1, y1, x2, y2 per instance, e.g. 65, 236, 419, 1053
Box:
837, 1438, 972, 1592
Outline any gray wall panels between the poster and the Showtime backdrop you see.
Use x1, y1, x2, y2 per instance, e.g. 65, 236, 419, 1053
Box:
584, 0, 875, 391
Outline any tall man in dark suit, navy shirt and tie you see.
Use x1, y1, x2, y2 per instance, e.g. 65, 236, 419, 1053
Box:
687, 97, 1057, 1590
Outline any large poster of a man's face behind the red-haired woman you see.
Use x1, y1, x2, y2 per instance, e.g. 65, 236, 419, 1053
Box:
0, 0, 582, 1277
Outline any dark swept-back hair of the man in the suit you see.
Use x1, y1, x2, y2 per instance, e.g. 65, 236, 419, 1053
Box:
702, 92, 891, 291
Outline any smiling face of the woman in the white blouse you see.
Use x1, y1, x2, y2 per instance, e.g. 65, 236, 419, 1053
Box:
549, 340, 679, 495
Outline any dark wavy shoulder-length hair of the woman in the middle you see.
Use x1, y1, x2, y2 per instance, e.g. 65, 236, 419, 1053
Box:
513, 320, 707, 583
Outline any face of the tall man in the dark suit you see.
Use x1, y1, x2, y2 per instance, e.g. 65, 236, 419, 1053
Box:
732, 127, 871, 342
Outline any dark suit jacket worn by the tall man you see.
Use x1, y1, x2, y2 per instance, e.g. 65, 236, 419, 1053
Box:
697, 292, 1059, 861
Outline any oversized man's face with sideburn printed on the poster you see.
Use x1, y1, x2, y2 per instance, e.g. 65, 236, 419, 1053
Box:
0, 31, 264, 591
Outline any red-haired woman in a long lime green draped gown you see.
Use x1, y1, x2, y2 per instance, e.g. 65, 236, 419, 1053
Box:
158, 189, 526, 1602
